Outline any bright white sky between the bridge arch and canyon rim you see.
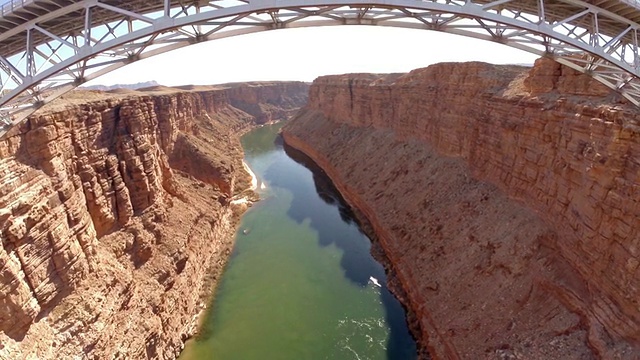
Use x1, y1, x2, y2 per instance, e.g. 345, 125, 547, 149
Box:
82, 26, 536, 86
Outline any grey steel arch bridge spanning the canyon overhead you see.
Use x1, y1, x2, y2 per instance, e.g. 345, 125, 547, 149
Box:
0, 0, 640, 136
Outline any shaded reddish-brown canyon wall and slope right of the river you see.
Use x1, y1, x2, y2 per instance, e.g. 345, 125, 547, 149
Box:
284, 59, 640, 359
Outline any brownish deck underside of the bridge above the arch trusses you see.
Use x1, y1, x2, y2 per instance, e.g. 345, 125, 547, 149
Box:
0, 0, 640, 57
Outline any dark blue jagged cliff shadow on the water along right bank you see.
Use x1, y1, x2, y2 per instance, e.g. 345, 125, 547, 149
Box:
264, 136, 416, 359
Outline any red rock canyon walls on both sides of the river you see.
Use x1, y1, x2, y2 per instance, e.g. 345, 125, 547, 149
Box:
0, 59, 640, 359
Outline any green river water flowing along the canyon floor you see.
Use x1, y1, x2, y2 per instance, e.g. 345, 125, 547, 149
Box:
180, 124, 416, 360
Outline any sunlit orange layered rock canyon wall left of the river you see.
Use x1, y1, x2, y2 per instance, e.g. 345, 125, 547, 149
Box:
0, 83, 308, 359
